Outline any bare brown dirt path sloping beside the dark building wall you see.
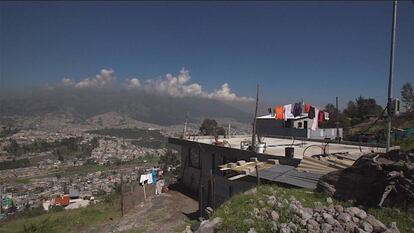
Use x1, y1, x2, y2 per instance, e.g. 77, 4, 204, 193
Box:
82, 190, 198, 233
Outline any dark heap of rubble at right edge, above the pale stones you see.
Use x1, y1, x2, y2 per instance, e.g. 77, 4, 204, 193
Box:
318, 150, 414, 206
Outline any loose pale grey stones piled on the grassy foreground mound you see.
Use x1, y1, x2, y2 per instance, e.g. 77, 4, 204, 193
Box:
196, 196, 400, 233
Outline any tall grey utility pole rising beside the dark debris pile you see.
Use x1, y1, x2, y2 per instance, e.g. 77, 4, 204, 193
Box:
386, 0, 397, 152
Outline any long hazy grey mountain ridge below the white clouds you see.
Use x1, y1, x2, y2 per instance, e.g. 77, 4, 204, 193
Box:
0, 88, 254, 125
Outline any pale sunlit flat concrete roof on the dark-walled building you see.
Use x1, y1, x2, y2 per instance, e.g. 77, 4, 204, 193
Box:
188, 135, 384, 160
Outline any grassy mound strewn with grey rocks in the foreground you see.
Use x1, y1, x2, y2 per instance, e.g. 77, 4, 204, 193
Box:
205, 187, 414, 233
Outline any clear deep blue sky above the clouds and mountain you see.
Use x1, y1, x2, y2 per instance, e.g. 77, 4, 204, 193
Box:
0, 1, 414, 105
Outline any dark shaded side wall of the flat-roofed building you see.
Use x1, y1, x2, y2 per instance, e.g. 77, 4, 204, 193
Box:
168, 138, 300, 218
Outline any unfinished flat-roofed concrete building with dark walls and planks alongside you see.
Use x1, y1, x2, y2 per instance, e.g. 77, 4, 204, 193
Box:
169, 136, 381, 215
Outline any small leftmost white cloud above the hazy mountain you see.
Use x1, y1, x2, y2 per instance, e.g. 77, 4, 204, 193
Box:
62, 69, 116, 88
